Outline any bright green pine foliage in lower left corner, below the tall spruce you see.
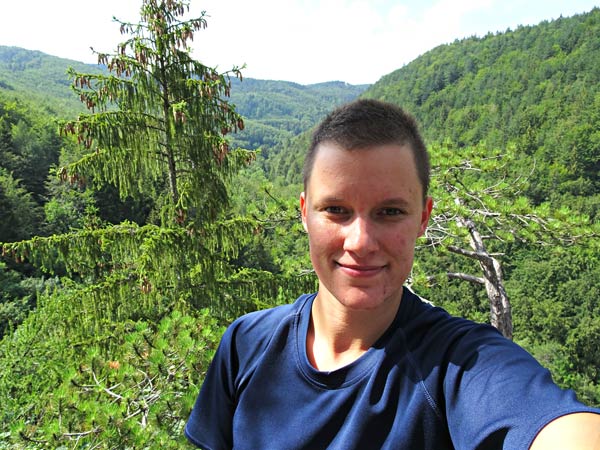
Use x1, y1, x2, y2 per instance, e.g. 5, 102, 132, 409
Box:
0, 286, 222, 448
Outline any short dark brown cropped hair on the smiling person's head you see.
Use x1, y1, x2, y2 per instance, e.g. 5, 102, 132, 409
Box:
302, 99, 430, 199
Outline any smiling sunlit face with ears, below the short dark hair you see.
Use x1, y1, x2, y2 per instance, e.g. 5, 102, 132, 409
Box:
300, 142, 432, 310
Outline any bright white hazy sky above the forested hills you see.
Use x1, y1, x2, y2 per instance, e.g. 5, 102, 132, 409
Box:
0, 0, 600, 84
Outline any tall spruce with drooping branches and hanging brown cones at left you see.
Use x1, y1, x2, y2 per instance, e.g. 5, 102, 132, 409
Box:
4, 0, 264, 320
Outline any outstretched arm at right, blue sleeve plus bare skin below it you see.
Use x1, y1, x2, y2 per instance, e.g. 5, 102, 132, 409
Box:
445, 330, 600, 450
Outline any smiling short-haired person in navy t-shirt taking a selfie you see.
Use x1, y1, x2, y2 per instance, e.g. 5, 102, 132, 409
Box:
185, 100, 600, 450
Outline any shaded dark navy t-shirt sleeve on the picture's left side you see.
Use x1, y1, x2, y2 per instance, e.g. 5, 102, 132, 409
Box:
184, 326, 237, 450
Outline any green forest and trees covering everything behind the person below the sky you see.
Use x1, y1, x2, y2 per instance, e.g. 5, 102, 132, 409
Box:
0, 0, 600, 448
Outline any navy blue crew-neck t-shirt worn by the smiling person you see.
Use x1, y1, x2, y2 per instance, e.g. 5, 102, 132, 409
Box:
185, 288, 600, 450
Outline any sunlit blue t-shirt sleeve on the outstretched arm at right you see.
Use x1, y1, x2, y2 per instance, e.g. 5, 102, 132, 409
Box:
443, 326, 600, 449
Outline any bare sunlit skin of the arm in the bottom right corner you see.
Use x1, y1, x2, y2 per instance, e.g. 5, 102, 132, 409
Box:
530, 413, 600, 450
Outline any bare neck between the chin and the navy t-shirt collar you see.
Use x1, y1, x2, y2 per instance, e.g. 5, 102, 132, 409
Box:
306, 292, 400, 371
